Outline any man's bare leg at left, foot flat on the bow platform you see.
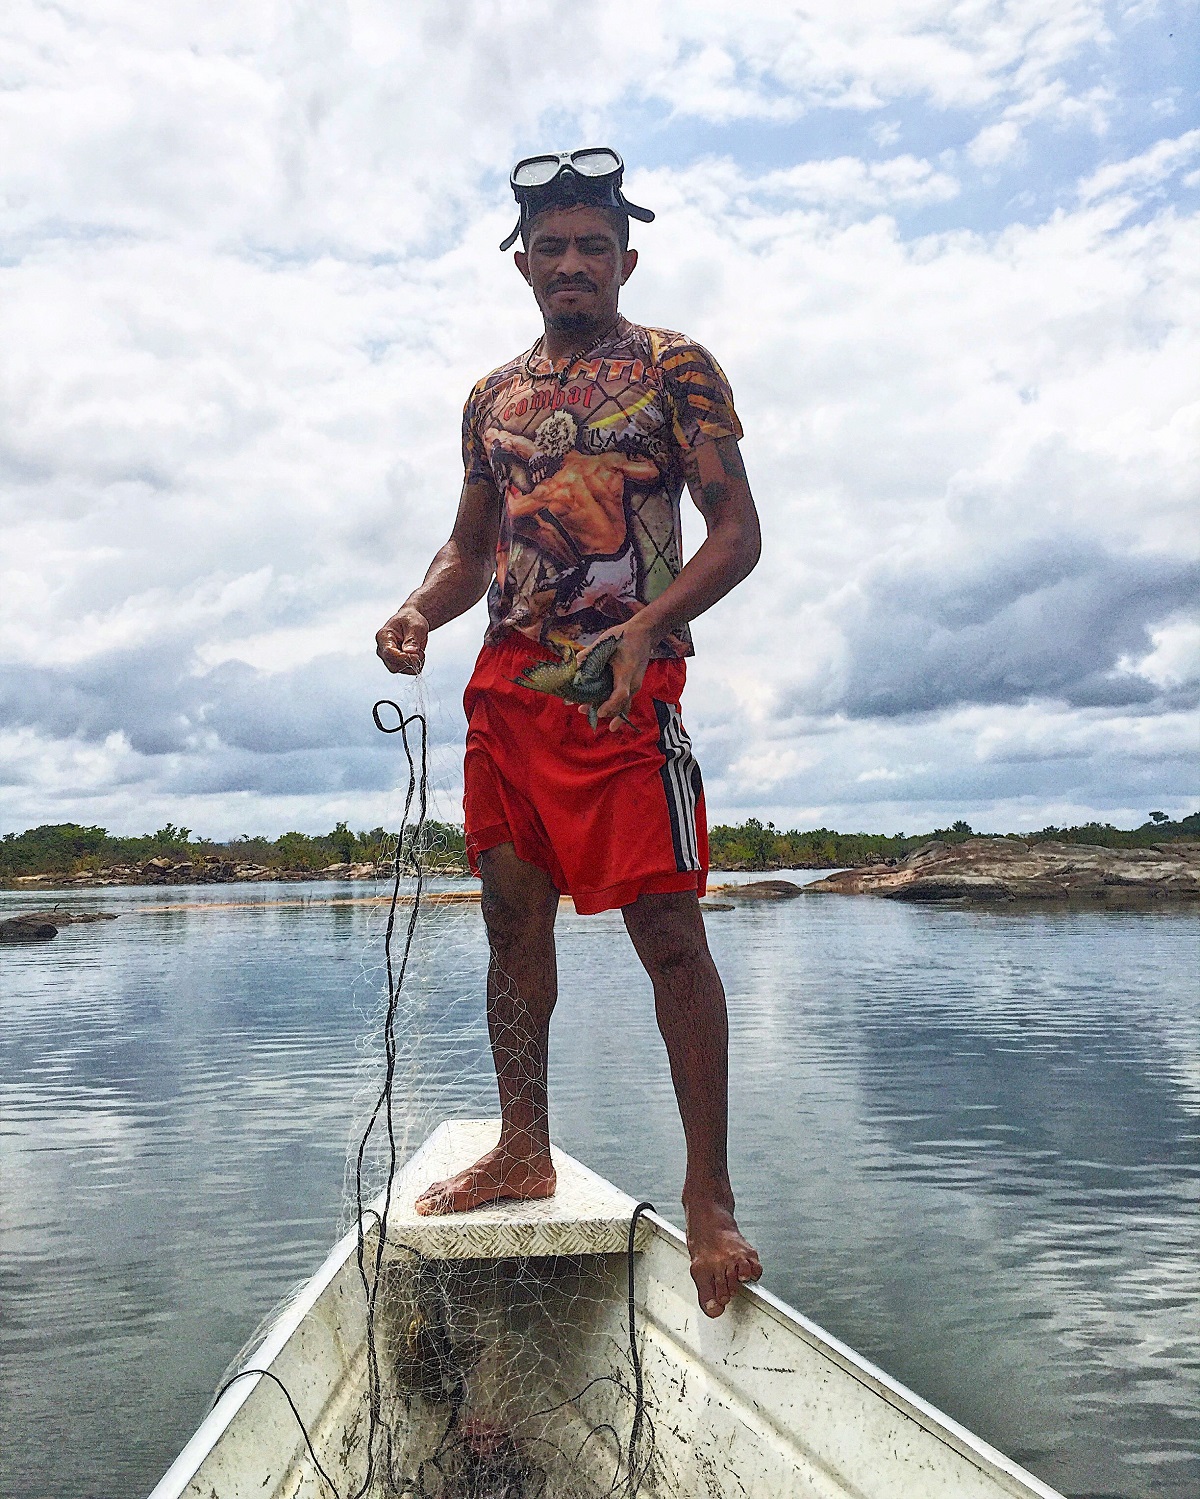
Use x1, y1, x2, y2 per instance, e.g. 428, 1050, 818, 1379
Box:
416, 844, 559, 1214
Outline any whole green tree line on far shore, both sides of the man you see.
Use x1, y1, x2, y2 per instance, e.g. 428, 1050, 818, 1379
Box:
0, 812, 1200, 880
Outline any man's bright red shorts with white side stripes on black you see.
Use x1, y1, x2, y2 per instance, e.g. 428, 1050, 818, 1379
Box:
463, 631, 709, 914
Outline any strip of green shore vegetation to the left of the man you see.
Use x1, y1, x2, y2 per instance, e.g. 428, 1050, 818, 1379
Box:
0, 821, 464, 880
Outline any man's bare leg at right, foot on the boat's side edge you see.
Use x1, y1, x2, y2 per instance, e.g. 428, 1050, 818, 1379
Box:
622, 892, 763, 1316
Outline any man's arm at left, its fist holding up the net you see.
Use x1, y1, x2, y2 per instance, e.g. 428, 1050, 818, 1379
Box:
375, 481, 500, 676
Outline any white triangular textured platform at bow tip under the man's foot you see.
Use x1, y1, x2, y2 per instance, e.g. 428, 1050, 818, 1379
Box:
373, 1120, 650, 1259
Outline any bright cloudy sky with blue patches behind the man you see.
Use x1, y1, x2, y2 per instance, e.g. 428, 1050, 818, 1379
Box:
0, 0, 1200, 836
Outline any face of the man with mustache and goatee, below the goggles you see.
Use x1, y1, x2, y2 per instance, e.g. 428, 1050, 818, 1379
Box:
514, 204, 638, 333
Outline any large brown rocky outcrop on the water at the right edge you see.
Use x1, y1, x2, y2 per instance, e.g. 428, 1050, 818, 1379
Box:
804, 838, 1200, 905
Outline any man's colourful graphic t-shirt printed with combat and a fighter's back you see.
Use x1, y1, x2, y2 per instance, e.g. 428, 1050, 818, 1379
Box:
463, 318, 742, 657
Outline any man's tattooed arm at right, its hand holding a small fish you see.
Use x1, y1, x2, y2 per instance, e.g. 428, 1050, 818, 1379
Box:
587, 438, 763, 729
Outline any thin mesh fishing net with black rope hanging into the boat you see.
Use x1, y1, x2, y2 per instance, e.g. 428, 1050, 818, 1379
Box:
205, 684, 668, 1499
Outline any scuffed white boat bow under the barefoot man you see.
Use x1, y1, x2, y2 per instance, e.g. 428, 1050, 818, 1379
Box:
151, 1121, 1061, 1499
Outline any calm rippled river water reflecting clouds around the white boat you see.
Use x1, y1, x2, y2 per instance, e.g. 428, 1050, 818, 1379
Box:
0, 875, 1200, 1499
